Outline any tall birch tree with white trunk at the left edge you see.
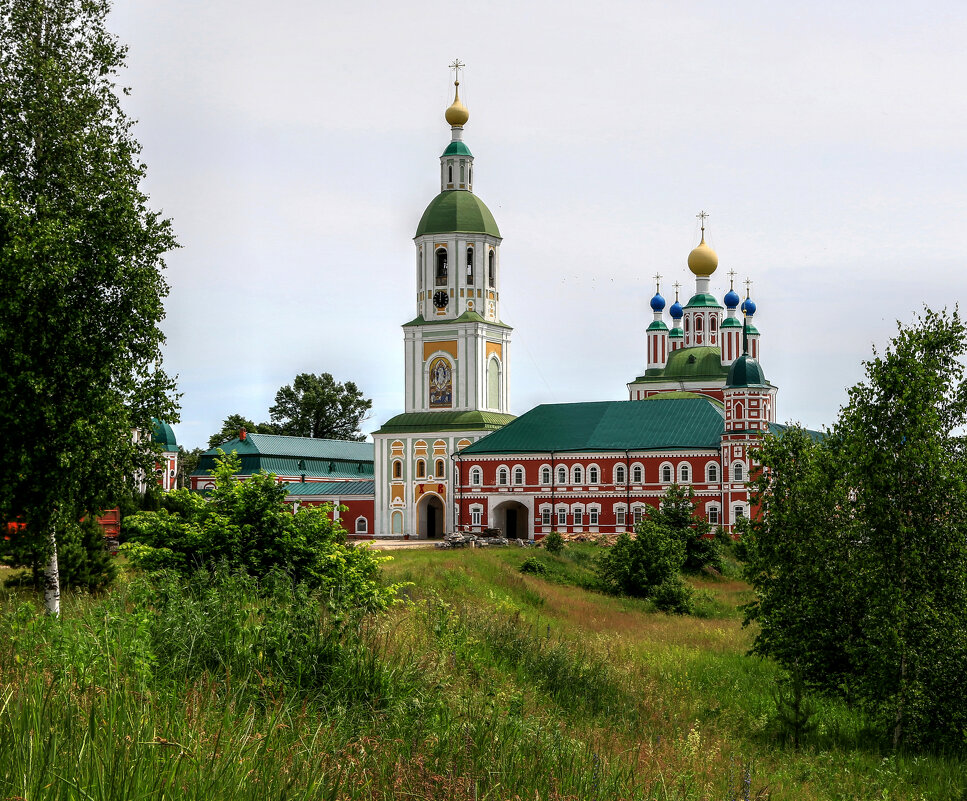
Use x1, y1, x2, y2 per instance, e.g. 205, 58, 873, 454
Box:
0, 0, 177, 613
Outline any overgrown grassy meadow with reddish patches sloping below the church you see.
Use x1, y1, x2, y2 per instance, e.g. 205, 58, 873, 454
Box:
0, 545, 967, 801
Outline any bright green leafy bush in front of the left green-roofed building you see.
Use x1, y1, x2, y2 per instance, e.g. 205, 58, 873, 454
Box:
122, 454, 397, 611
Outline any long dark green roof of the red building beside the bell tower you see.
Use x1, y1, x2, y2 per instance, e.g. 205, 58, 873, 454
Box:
461, 397, 724, 455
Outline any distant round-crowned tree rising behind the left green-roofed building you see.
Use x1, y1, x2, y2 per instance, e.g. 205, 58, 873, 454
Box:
269, 373, 373, 441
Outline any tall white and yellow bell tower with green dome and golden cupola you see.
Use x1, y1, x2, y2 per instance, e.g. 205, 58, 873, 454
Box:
373, 60, 513, 538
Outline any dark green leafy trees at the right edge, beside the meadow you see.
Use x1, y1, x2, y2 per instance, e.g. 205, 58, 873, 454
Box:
745, 310, 967, 750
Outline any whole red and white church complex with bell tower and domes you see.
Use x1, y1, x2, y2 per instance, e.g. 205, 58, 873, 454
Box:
192, 69, 782, 539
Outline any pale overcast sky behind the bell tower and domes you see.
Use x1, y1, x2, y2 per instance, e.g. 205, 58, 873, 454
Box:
111, 0, 967, 447
